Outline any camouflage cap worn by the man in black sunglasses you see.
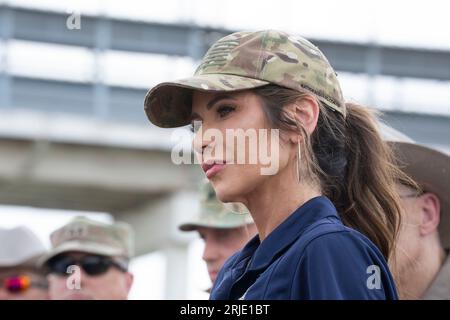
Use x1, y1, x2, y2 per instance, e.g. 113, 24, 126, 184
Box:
41, 216, 133, 264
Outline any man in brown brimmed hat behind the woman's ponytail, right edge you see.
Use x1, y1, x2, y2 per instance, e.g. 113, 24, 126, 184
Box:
382, 126, 450, 300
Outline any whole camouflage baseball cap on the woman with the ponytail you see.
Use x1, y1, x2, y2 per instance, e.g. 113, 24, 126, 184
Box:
144, 30, 345, 128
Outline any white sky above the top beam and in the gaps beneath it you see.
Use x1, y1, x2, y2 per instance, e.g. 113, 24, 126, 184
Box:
0, 0, 450, 115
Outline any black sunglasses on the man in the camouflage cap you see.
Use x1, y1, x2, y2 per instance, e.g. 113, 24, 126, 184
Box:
47, 255, 128, 276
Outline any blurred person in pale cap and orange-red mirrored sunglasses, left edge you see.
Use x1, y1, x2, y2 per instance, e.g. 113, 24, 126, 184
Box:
0, 227, 48, 300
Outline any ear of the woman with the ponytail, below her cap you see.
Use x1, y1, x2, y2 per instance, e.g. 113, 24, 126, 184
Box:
287, 95, 320, 143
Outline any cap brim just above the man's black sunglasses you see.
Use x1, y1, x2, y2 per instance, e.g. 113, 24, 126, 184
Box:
38, 240, 129, 266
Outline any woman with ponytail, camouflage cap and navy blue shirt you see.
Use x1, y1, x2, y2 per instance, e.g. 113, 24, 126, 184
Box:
144, 30, 402, 300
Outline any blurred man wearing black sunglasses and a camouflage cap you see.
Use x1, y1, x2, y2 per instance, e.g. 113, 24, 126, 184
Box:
42, 217, 133, 300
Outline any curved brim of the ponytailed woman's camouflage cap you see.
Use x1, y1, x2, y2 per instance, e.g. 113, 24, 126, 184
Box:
144, 74, 269, 128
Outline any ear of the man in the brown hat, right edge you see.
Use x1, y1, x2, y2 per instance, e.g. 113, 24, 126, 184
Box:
417, 192, 441, 236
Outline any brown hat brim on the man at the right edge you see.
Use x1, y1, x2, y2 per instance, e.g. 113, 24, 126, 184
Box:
390, 141, 450, 248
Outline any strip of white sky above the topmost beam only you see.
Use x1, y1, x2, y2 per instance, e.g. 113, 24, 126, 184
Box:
5, 0, 450, 49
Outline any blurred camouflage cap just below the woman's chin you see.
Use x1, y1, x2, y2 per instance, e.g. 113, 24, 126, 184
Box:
179, 181, 253, 231
